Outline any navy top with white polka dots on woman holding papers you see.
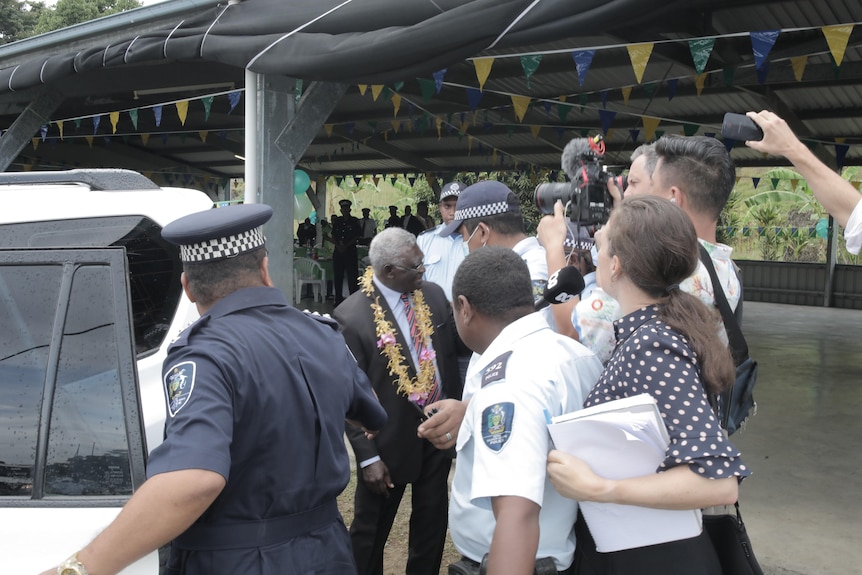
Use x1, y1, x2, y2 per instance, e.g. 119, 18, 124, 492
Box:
584, 306, 751, 480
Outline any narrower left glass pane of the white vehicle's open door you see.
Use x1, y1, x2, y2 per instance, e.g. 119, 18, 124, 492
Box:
0, 266, 63, 495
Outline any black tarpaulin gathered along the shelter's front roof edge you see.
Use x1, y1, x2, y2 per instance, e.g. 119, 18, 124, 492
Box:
0, 0, 668, 92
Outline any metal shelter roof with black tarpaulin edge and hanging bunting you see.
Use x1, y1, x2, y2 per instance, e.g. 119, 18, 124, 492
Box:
0, 0, 862, 187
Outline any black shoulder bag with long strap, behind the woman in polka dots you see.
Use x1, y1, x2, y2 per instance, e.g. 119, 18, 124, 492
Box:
700, 245, 757, 435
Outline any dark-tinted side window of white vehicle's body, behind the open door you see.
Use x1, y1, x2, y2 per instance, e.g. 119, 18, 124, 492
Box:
0, 216, 182, 357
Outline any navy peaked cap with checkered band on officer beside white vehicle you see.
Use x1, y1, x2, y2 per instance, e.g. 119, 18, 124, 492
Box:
162, 204, 272, 263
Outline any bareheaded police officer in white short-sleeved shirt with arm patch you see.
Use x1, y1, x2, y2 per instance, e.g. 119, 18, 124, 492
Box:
446, 247, 602, 575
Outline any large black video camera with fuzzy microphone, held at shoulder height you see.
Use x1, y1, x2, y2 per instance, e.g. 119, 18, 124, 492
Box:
533, 135, 628, 225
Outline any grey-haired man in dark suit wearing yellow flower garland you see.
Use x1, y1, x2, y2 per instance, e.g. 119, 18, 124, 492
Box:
335, 228, 462, 575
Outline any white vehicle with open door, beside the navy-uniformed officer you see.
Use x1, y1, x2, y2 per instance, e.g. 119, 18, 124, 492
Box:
0, 170, 213, 575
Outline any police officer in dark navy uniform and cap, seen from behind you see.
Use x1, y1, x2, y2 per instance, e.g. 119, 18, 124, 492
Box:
46, 204, 386, 575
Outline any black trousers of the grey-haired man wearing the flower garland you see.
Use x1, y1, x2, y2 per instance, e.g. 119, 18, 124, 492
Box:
350, 441, 452, 575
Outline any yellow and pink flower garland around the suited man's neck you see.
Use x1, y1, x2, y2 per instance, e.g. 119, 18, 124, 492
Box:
359, 267, 436, 406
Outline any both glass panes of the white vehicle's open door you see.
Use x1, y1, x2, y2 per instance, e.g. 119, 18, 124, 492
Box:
0, 264, 132, 496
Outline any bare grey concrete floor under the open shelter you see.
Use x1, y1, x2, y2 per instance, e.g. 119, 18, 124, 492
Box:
297, 300, 862, 575
